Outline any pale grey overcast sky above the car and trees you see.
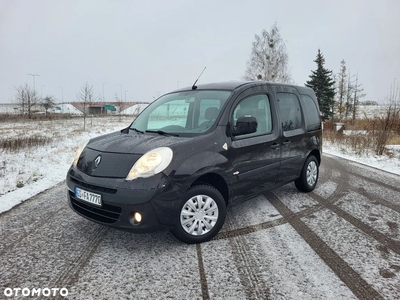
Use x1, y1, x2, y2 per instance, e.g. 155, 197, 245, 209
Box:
0, 0, 400, 103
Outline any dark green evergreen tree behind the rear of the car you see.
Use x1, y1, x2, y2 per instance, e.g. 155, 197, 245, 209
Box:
305, 49, 335, 120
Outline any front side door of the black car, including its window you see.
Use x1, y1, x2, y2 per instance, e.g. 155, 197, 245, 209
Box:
228, 90, 280, 202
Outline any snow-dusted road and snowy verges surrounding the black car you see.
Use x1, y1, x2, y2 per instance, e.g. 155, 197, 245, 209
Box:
0, 117, 400, 300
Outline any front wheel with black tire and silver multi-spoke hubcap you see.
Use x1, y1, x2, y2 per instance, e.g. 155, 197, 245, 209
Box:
172, 185, 226, 244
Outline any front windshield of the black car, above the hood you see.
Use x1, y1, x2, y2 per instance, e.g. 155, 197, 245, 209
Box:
130, 90, 231, 135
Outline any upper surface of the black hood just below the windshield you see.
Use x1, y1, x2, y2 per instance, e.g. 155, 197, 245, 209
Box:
87, 131, 186, 155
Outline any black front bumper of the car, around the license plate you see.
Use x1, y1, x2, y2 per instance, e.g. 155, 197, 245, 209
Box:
66, 167, 185, 233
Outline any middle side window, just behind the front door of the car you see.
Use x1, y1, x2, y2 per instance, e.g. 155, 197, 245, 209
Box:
277, 93, 303, 131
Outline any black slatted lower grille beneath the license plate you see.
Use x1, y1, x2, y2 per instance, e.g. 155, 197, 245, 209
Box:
69, 191, 121, 224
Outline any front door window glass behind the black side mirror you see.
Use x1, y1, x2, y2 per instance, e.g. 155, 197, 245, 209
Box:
232, 94, 272, 138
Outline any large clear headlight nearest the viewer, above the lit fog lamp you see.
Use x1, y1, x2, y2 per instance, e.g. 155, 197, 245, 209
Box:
126, 147, 173, 180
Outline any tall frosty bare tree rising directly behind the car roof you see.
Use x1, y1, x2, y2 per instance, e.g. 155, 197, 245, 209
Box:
244, 23, 292, 83
